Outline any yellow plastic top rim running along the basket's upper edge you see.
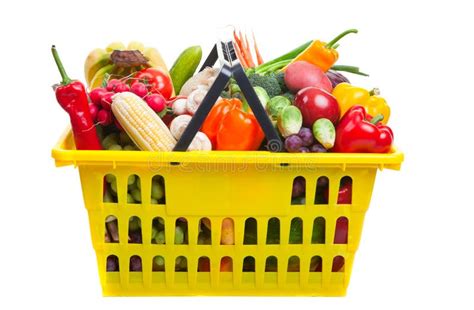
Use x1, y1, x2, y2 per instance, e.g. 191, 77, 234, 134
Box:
51, 126, 404, 170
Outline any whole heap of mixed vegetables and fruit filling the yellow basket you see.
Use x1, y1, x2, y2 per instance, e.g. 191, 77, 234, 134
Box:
52, 29, 393, 271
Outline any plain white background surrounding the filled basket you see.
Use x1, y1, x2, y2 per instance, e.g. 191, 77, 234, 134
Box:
0, 0, 474, 309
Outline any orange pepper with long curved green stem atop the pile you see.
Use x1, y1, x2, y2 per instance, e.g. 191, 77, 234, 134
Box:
283, 29, 357, 72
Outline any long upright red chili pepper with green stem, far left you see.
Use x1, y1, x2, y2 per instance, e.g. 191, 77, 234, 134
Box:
51, 45, 102, 150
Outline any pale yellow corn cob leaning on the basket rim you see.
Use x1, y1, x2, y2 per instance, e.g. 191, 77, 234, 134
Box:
112, 92, 176, 151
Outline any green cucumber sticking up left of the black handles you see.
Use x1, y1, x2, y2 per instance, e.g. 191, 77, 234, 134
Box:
170, 46, 202, 94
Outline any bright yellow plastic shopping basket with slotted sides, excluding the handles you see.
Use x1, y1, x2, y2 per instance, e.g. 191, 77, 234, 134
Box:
53, 130, 403, 296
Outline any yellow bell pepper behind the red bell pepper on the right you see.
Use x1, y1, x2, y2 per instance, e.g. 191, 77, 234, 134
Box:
332, 83, 390, 125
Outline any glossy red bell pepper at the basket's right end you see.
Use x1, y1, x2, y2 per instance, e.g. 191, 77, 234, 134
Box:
333, 105, 393, 153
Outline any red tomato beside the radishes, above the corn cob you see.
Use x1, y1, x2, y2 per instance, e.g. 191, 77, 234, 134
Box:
132, 68, 173, 100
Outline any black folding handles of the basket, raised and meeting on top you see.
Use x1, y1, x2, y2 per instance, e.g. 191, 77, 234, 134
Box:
173, 41, 283, 152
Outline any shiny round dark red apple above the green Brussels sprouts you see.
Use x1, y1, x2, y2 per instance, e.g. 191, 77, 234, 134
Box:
295, 87, 341, 128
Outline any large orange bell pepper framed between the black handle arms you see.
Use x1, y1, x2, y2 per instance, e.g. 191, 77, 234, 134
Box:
201, 98, 265, 151
